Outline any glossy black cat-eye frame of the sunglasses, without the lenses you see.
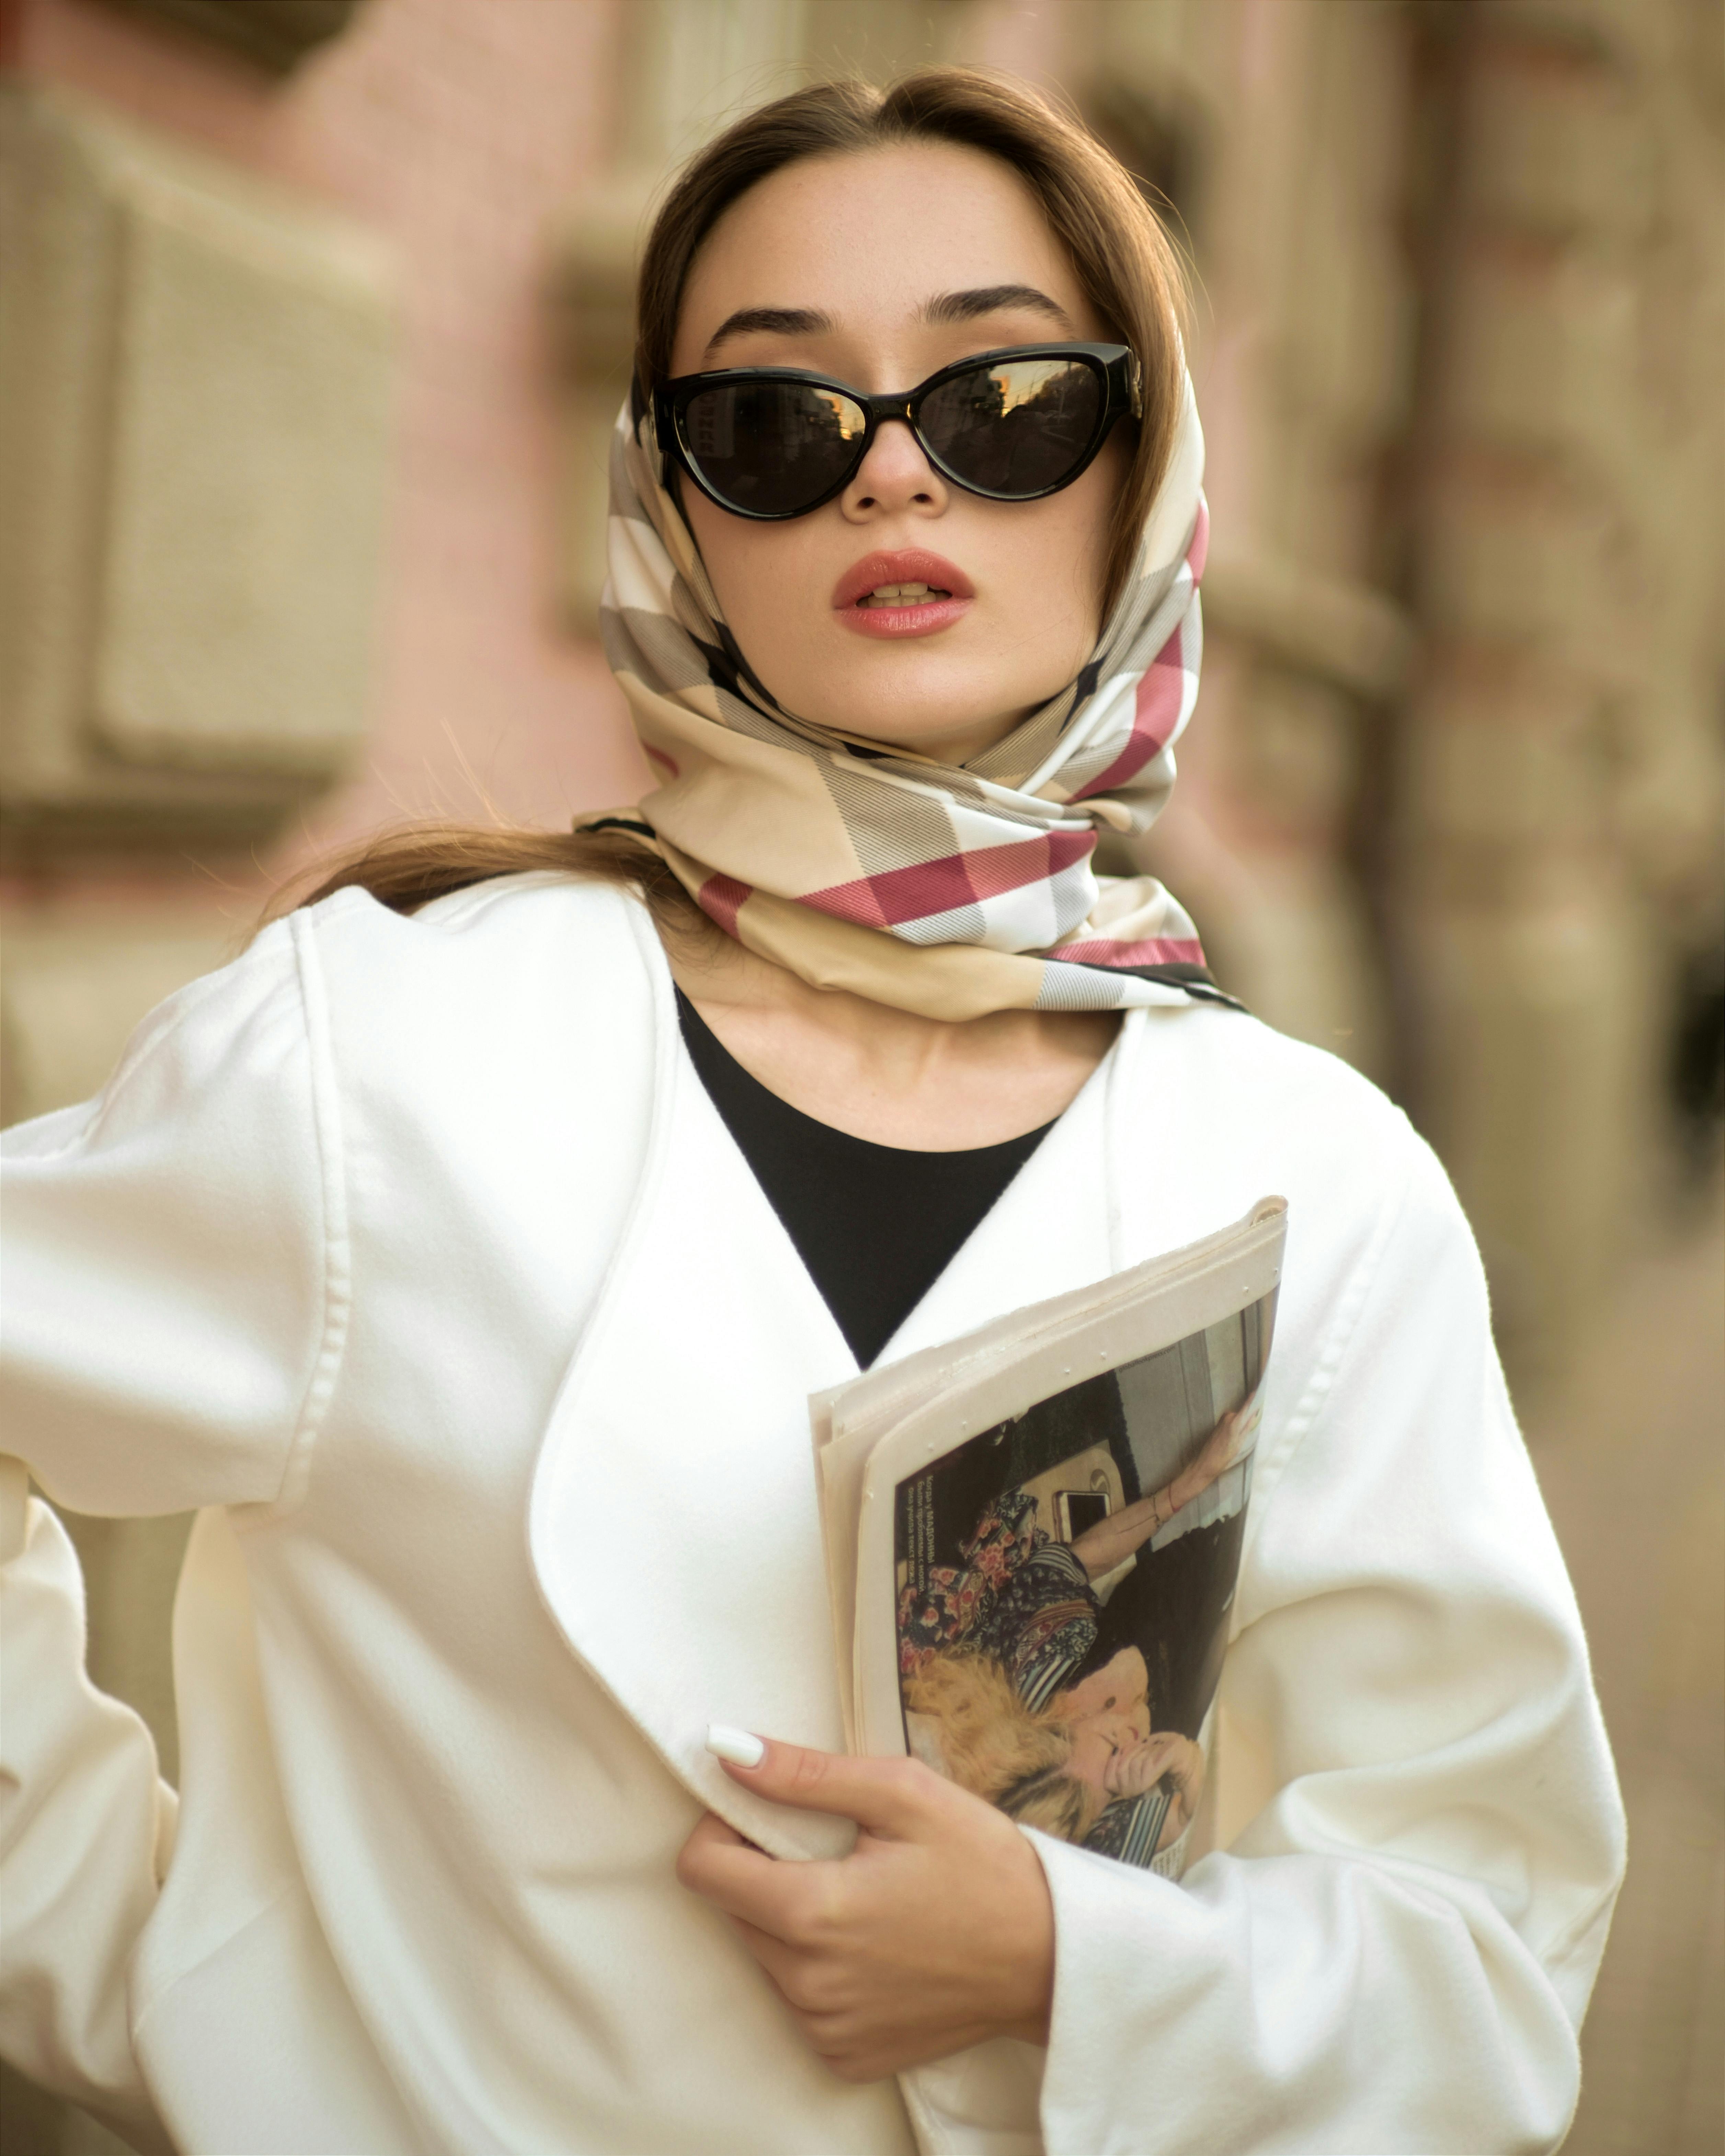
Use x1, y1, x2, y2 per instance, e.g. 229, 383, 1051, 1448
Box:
653, 345, 1143, 524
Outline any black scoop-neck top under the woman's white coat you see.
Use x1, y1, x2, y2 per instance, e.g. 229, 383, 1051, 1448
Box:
677, 990, 1054, 1369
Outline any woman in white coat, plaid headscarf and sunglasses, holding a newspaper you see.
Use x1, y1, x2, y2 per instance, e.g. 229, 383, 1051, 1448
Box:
0, 59, 1622, 2156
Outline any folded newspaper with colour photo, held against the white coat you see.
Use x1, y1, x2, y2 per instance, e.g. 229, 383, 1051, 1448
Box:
811, 1199, 1287, 1878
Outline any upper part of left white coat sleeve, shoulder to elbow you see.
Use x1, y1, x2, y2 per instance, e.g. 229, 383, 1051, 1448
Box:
0, 916, 345, 1518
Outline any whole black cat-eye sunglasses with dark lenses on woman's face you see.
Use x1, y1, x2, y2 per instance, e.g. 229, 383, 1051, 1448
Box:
653, 345, 1141, 522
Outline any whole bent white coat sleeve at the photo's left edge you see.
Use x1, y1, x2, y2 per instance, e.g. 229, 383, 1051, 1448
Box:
0, 921, 345, 2121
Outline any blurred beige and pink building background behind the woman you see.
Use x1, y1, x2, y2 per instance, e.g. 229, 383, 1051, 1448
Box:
0, 0, 1725, 2156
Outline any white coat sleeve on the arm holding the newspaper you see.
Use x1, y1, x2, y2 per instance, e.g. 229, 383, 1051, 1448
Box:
1035, 1145, 1624, 2156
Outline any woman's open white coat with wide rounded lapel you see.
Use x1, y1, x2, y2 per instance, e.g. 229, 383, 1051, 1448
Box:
0, 875, 1622, 2156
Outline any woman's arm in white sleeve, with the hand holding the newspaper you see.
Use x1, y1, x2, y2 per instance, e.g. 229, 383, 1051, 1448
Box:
679, 1147, 1622, 2156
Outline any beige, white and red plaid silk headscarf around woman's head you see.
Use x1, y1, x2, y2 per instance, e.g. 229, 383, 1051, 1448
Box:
582, 382, 1231, 1020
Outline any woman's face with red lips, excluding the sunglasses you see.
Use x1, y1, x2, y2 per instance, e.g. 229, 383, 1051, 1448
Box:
673, 142, 1128, 763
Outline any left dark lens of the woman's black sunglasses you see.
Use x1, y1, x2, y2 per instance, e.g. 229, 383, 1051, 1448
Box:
684, 382, 869, 517
